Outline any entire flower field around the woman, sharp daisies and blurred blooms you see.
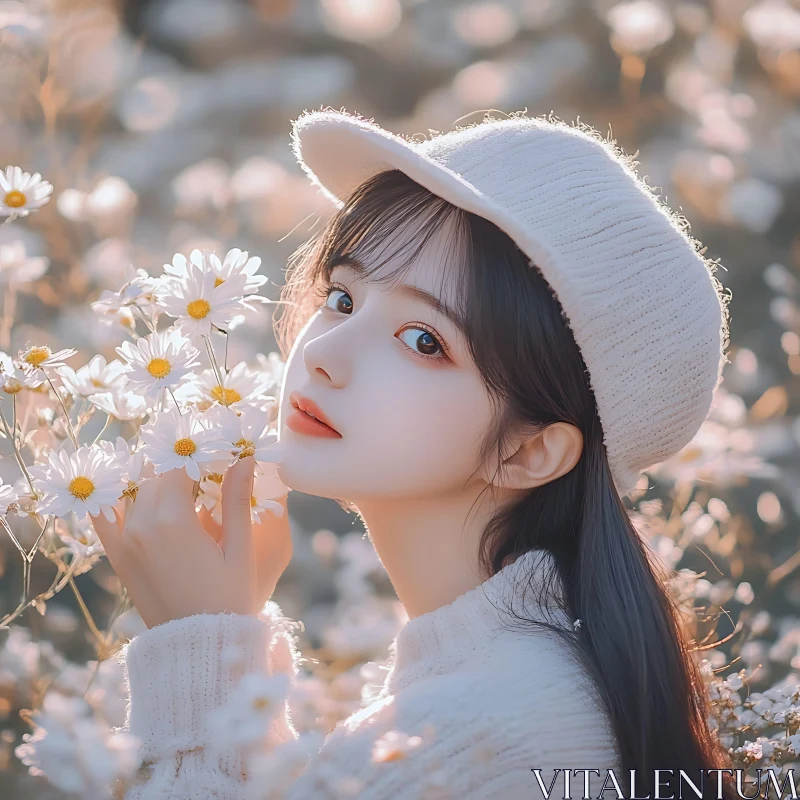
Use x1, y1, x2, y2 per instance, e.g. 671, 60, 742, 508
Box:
0, 0, 800, 800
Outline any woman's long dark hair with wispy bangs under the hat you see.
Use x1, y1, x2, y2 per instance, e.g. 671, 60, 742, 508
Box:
275, 170, 733, 797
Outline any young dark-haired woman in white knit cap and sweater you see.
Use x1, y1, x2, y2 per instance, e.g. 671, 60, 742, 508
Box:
94, 110, 731, 800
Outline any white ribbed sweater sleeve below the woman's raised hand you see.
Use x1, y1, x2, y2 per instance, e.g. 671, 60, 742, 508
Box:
122, 603, 297, 800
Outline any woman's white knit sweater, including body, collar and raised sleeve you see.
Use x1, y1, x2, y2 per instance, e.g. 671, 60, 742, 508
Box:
117, 550, 619, 800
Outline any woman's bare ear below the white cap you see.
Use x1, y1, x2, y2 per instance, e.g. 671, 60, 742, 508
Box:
492, 422, 583, 489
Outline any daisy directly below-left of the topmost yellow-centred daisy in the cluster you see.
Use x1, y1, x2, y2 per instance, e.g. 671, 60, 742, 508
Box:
117, 328, 200, 397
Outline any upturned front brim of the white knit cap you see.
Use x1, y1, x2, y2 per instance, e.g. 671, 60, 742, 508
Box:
292, 110, 561, 278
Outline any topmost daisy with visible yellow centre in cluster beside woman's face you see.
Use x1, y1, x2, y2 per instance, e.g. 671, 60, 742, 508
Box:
158, 265, 245, 337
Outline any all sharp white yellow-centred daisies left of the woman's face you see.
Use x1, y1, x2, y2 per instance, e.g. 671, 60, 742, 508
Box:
0, 168, 288, 625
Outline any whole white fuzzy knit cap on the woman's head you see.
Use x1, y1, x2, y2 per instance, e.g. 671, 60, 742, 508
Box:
292, 108, 728, 495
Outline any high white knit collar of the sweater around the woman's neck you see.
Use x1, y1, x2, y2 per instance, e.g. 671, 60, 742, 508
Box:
384, 549, 573, 693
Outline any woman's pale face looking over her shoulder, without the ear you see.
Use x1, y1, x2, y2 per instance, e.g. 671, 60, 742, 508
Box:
278, 212, 500, 504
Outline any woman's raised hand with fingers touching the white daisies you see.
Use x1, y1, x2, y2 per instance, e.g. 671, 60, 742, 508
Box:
92, 457, 292, 628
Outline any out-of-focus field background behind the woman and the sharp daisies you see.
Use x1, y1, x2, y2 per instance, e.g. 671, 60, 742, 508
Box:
0, 0, 800, 800
